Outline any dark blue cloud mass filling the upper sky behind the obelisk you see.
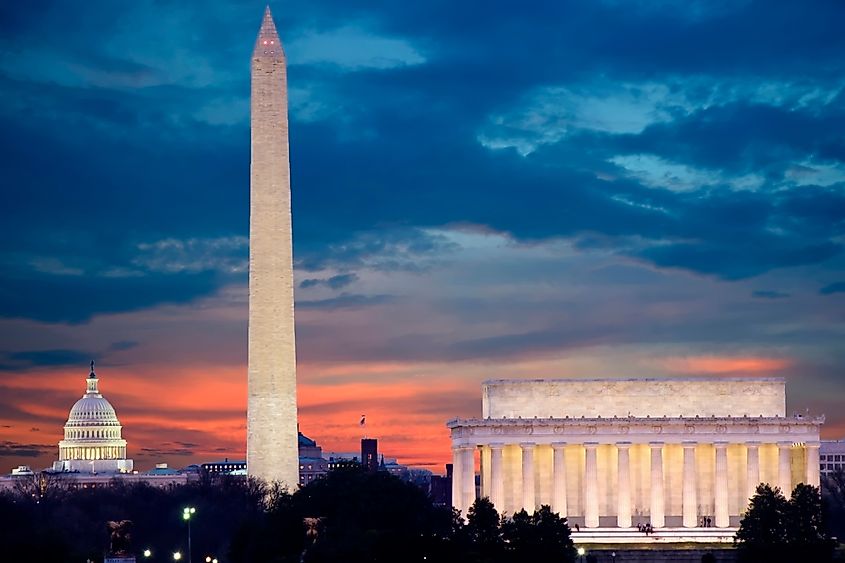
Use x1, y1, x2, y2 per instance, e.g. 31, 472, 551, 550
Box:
0, 0, 845, 322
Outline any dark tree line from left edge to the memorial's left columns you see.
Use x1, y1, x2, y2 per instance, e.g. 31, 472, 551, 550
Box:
0, 468, 574, 563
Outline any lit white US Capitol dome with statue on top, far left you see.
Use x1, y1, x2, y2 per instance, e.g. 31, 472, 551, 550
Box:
53, 362, 133, 473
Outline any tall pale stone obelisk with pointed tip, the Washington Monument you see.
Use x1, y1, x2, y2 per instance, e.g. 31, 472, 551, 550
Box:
246, 7, 299, 491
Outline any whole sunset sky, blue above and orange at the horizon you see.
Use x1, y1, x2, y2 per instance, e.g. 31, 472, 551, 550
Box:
0, 0, 845, 472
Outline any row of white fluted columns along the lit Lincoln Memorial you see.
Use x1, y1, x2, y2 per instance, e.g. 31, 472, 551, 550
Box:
452, 442, 819, 528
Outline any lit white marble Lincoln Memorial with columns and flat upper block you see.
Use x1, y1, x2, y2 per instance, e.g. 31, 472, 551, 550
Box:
447, 378, 824, 537
